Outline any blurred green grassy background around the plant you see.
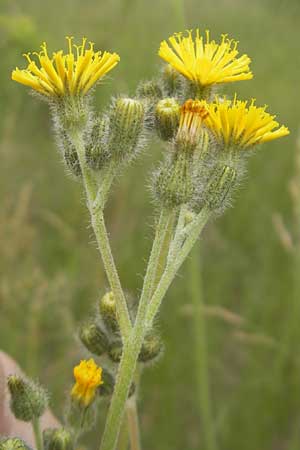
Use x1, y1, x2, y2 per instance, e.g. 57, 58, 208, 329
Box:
0, 0, 300, 450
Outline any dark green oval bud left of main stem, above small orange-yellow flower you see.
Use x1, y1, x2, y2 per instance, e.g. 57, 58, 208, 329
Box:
79, 322, 109, 356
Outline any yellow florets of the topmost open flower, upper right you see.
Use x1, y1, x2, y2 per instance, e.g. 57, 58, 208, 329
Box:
158, 29, 253, 86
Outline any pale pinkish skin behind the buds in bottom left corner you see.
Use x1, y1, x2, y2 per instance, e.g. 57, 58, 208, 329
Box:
0, 351, 59, 448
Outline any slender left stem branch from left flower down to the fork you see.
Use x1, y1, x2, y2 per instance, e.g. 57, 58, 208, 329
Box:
71, 130, 132, 340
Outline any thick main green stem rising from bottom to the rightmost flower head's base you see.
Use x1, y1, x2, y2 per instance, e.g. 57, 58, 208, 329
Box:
101, 209, 210, 450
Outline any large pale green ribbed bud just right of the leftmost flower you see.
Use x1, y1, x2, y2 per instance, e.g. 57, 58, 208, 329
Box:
108, 97, 145, 162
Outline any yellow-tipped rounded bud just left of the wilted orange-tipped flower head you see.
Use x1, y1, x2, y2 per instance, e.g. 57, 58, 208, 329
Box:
155, 97, 180, 141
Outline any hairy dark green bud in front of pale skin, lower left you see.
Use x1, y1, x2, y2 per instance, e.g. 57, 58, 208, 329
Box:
7, 375, 48, 422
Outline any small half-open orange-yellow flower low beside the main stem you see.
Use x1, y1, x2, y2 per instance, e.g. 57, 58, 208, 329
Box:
71, 359, 103, 406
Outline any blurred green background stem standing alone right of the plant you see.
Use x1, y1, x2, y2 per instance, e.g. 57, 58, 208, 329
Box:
188, 247, 217, 450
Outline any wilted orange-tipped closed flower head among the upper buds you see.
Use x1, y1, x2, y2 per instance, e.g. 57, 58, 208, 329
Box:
176, 99, 208, 149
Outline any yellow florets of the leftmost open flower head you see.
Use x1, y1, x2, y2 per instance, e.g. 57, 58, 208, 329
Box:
12, 37, 120, 97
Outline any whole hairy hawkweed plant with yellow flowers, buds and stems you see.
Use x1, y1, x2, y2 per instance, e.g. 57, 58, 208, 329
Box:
1, 30, 289, 450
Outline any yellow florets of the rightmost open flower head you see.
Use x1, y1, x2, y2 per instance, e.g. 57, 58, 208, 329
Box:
205, 97, 290, 148
